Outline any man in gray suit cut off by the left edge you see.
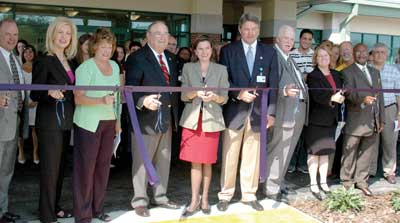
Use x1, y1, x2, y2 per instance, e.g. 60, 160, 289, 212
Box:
0, 19, 28, 223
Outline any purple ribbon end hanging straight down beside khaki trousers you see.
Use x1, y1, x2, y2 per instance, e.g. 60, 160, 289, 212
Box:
260, 90, 268, 182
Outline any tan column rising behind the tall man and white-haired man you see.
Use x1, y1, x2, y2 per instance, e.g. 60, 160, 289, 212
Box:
260, 0, 297, 43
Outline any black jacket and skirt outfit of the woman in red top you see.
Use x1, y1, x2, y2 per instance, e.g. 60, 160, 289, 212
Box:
304, 68, 342, 155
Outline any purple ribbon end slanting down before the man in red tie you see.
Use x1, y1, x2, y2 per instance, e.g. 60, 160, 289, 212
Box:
124, 90, 160, 186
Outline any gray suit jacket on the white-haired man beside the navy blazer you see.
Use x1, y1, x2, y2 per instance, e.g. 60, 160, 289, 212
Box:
275, 45, 309, 128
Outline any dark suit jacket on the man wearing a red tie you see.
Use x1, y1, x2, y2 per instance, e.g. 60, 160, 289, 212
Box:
125, 44, 179, 135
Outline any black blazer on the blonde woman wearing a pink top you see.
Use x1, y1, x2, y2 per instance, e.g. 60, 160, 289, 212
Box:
30, 55, 76, 130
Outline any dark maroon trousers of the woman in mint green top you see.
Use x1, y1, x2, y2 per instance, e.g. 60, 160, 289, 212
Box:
73, 120, 115, 223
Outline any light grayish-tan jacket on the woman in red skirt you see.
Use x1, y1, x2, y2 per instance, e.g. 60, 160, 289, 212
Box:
179, 62, 229, 132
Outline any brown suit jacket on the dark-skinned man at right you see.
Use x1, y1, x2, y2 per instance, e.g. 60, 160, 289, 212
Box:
342, 63, 385, 136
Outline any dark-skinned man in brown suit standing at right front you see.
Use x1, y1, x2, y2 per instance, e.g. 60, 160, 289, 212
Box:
340, 44, 385, 196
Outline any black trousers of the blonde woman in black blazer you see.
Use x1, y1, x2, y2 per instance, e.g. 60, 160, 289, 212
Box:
38, 129, 71, 222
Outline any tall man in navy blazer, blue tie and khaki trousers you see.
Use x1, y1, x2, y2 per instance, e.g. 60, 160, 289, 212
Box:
217, 14, 278, 211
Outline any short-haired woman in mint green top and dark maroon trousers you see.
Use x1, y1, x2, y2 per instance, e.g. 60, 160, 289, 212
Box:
73, 28, 121, 223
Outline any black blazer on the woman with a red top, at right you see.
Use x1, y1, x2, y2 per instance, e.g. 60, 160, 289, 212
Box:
307, 67, 343, 126
